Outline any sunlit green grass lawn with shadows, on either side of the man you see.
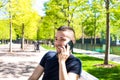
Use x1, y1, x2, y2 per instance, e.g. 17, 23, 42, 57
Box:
43, 45, 120, 80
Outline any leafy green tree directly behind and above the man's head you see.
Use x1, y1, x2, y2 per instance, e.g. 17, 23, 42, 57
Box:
45, 0, 87, 39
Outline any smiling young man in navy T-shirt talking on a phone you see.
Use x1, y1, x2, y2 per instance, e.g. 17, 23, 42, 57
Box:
29, 26, 81, 80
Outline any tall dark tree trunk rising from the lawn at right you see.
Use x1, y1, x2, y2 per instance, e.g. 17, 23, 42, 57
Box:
104, 0, 110, 65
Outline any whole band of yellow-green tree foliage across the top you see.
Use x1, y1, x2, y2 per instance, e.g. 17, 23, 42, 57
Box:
0, 0, 120, 43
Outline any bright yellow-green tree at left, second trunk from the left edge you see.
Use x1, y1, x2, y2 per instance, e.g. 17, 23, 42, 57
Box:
8, 0, 40, 50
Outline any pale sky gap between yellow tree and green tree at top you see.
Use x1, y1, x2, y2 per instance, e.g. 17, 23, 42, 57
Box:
33, 0, 49, 16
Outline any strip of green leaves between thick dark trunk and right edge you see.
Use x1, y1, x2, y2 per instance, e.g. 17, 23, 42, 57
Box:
110, 1, 120, 40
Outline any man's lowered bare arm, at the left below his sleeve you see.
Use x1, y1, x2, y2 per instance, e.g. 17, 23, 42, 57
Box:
28, 65, 44, 80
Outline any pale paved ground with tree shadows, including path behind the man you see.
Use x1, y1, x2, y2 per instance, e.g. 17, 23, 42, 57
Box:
0, 44, 120, 80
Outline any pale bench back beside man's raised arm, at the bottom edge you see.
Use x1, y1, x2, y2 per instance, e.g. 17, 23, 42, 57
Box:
79, 70, 99, 80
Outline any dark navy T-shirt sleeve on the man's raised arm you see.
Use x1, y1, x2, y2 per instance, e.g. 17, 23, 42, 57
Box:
69, 59, 82, 75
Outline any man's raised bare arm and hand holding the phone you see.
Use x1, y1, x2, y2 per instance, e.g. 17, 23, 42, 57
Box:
58, 46, 79, 80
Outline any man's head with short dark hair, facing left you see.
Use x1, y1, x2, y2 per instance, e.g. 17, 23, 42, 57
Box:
55, 26, 75, 52
